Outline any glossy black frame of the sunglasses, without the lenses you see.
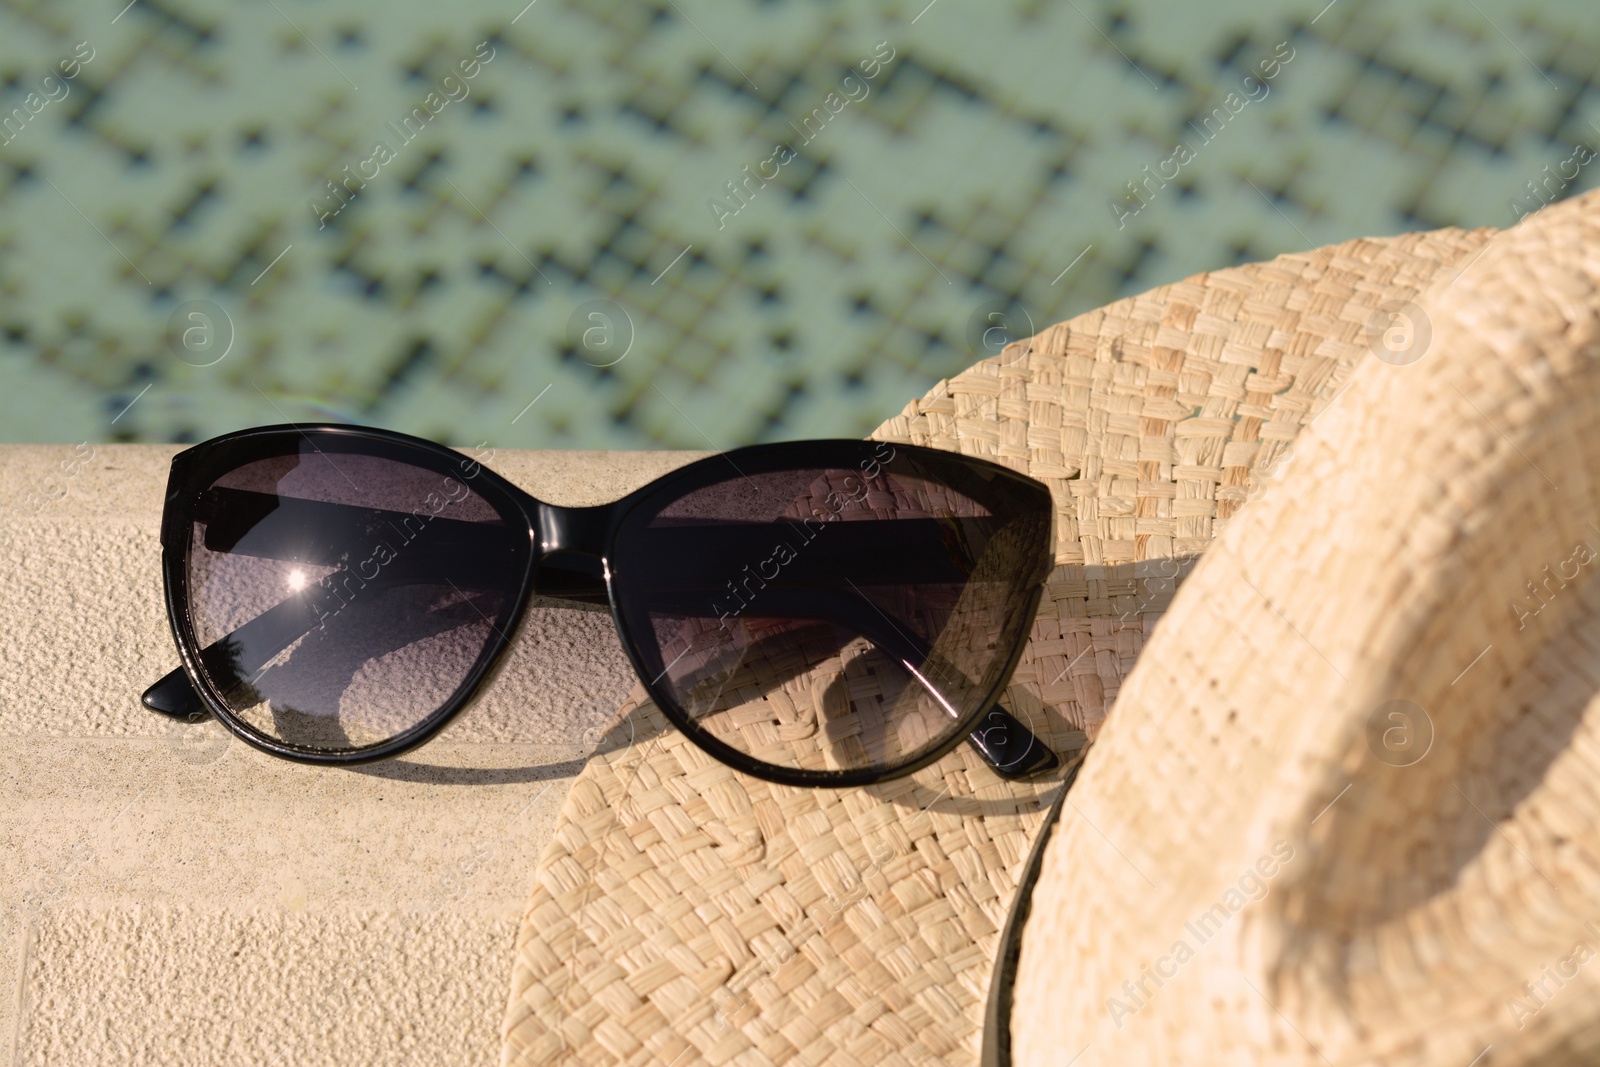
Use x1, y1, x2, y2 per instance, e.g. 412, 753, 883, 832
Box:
142, 424, 1059, 787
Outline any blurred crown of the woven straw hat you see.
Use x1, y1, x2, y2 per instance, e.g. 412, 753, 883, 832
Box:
1013, 194, 1600, 1067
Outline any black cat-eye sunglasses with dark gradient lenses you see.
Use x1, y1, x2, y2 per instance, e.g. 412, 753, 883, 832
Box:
144, 426, 1059, 785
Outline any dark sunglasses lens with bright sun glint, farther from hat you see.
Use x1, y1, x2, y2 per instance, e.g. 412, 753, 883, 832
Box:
187, 451, 526, 750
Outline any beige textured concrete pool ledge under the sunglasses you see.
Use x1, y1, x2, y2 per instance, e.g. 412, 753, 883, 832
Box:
0, 445, 699, 1067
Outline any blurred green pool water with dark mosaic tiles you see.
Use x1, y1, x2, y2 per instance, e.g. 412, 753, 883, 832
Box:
0, 0, 1600, 448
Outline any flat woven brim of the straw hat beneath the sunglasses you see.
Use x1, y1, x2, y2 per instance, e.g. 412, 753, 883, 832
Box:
502, 214, 1484, 1067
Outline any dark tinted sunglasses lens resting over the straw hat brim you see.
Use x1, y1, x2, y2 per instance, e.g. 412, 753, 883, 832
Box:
614, 446, 1050, 771
